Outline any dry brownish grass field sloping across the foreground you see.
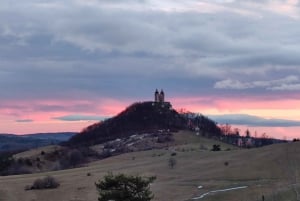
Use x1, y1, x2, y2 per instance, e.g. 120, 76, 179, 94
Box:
0, 133, 300, 201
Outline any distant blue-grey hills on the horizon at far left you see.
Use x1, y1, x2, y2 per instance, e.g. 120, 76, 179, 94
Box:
0, 132, 76, 151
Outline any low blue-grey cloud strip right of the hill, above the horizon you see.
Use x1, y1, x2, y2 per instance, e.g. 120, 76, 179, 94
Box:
209, 114, 300, 127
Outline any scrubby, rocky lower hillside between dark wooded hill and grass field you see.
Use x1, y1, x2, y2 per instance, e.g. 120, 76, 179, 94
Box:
0, 131, 230, 175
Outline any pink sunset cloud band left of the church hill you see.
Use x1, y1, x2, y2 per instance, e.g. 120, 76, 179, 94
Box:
0, 98, 128, 134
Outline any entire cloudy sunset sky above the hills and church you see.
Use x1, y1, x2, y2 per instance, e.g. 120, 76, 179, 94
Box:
0, 0, 300, 138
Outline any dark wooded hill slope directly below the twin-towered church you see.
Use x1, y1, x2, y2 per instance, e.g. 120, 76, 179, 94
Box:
67, 101, 188, 146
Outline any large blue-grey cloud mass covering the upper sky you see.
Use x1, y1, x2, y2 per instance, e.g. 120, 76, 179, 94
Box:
0, 0, 300, 105
